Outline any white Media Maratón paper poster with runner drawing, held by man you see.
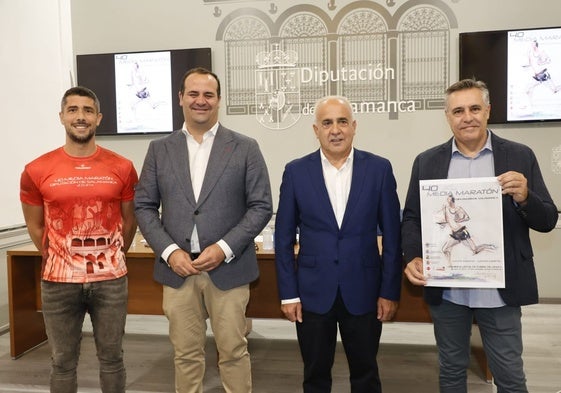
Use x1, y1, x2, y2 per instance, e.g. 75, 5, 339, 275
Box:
420, 177, 505, 288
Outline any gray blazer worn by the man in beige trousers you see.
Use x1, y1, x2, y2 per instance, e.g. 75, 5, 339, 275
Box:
134, 125, 272, 290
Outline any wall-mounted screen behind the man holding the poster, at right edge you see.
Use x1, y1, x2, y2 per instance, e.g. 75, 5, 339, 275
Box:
459, 27, 561, 124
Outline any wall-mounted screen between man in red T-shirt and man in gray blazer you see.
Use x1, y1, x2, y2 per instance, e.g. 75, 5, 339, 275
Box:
76, 48, 212, 135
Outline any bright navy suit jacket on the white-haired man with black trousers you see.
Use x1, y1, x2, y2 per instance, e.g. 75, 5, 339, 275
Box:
275, 149, 401, 315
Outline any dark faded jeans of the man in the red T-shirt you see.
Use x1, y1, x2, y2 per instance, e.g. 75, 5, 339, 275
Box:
41, 276, 128, 393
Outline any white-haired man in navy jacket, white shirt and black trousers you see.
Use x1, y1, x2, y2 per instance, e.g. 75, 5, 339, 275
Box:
275, 96, 401, 393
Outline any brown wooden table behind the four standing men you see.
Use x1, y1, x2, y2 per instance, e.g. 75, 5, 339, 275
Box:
3, 240, 491, 381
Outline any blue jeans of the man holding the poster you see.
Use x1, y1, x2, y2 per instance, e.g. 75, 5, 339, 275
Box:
430, 300, 528, 393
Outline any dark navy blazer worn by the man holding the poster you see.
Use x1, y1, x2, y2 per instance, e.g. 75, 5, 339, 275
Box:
402, 133, 557, 306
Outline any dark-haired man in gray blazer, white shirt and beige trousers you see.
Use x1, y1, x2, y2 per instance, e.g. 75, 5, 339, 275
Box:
135, 68, 272, 393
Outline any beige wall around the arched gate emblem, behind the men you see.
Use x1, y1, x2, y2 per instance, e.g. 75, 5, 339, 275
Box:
72, 0, 561, 298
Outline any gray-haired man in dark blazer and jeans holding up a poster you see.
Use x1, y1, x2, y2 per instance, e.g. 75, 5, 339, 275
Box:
402, 79, 558, 393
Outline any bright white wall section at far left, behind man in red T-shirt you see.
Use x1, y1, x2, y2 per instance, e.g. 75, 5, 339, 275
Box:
0, 0, 73, 228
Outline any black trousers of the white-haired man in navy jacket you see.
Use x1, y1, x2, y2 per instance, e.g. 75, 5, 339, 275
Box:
296, 293, 382, 393
